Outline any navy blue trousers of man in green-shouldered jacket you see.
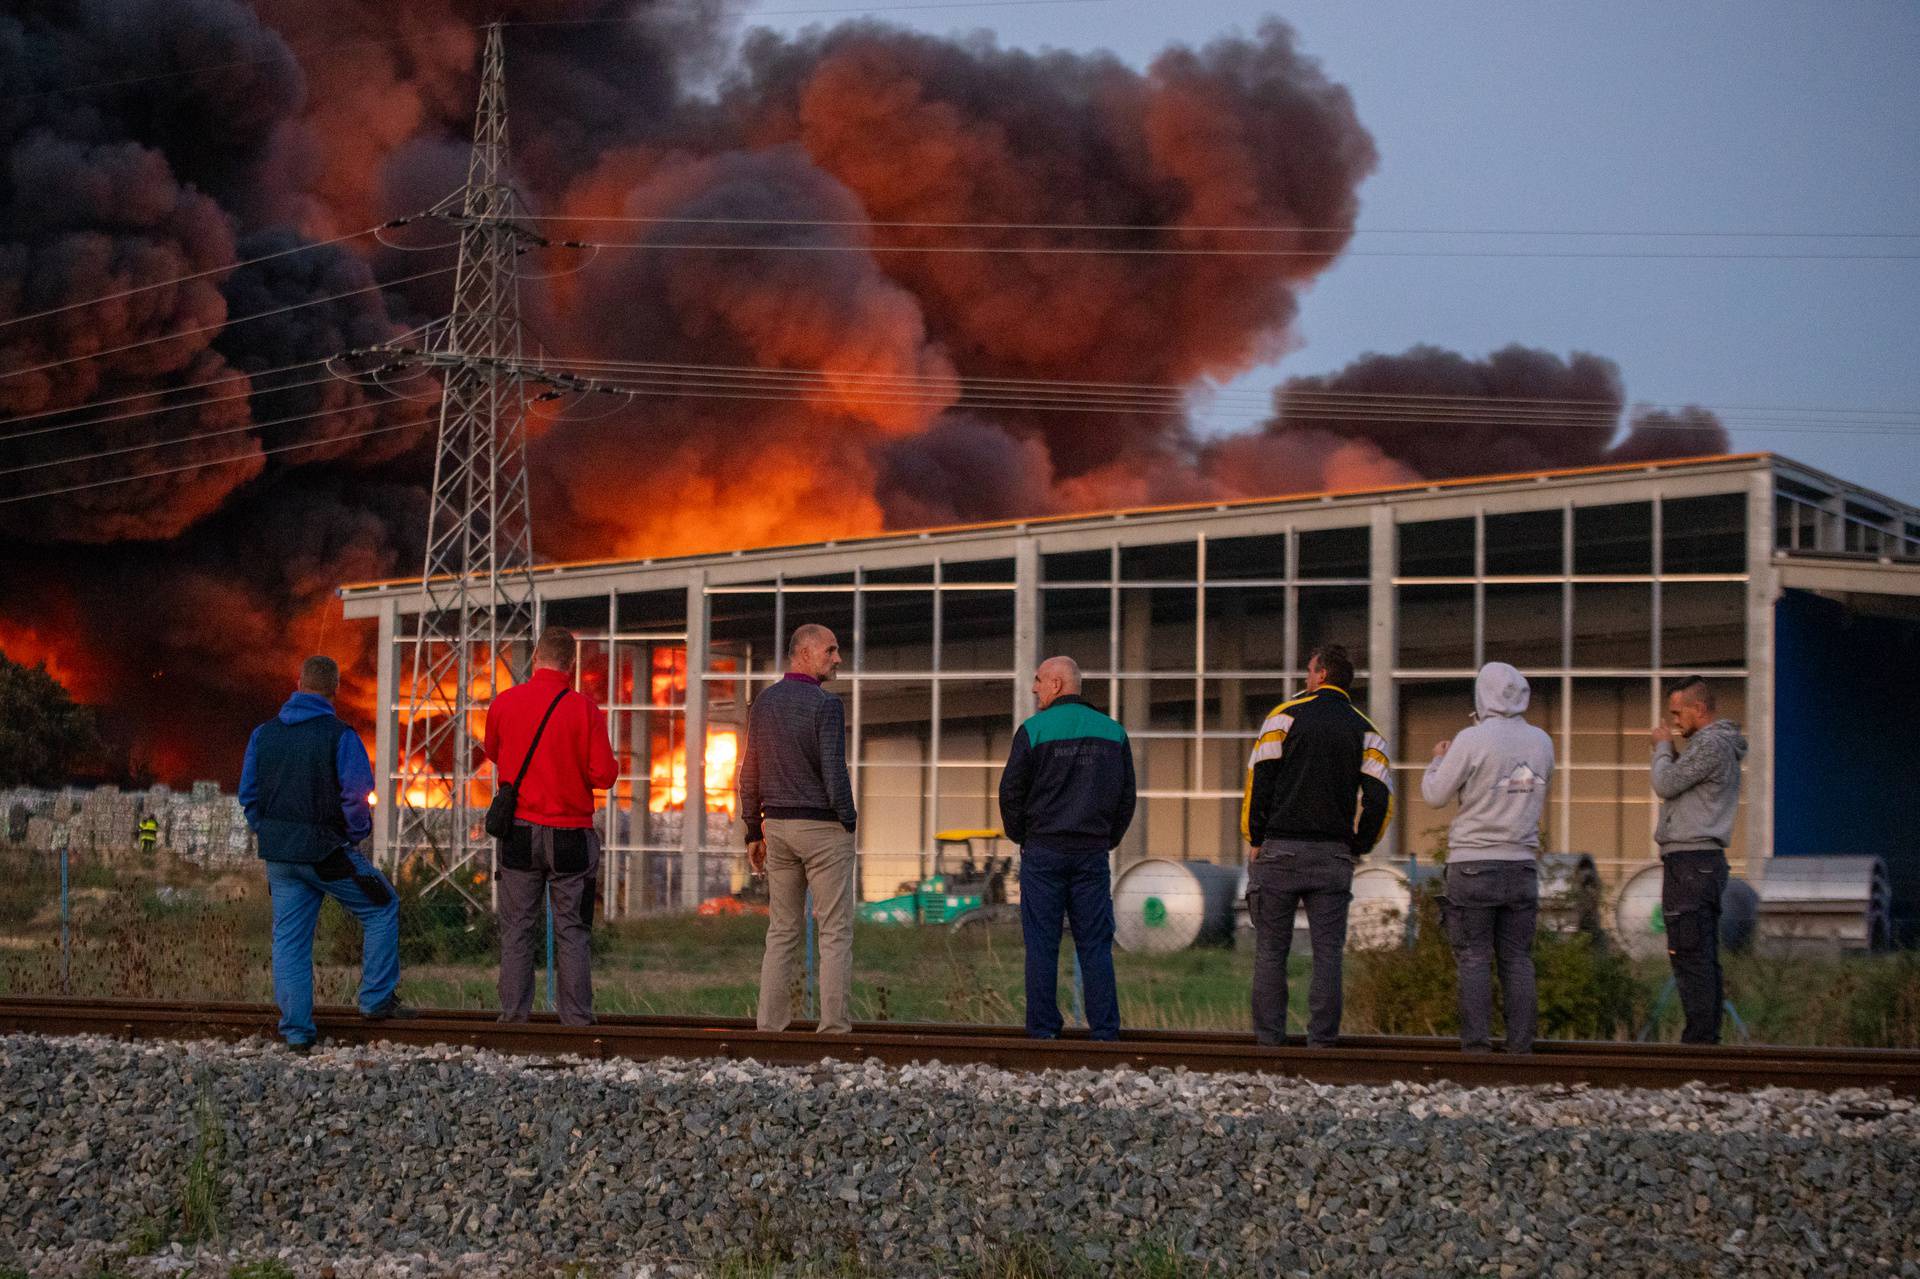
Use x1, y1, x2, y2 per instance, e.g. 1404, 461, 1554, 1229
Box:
1020, 849, 1119, 1039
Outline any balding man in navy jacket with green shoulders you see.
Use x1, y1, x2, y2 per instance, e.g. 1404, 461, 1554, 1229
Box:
1000, 657, 1135, 1039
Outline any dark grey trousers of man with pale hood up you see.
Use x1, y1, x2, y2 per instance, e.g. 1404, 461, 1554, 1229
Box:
1446, 860, 1540, 1052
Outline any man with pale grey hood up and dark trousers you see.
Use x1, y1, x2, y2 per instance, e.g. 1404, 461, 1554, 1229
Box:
1421, 663, 1553, 1052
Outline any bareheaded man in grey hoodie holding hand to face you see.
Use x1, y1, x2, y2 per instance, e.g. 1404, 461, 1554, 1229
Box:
1653, 676, 1747, 1043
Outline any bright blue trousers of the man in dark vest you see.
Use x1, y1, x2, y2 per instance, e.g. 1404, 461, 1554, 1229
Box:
267, 853, 399, 1043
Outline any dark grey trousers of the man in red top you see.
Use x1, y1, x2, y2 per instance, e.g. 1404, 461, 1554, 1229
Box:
499, 822, 599, 1026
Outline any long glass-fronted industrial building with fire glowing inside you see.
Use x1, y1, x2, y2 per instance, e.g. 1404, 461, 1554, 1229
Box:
342, 453, 1920, 933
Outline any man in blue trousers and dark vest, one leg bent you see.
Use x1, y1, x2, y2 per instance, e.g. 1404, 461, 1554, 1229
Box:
240, 657, 413, 1052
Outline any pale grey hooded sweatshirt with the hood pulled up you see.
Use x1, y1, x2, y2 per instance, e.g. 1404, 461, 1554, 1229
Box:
1421, 663, 1553, 862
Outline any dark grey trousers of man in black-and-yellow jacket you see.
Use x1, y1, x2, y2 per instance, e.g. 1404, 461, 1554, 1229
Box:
1246, 839, 1354, 1047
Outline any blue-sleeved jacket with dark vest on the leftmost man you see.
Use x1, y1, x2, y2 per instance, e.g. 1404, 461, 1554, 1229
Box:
240, 693, 374, 864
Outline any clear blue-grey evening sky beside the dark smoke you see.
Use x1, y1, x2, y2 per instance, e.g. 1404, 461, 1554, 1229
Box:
755, 0, 1920, 501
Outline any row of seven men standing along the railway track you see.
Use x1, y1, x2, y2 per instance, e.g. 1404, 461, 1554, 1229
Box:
240, 624, 1747, 1052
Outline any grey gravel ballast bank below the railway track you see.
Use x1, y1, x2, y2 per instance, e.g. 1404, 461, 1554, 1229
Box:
0, 1035, 1920, 1279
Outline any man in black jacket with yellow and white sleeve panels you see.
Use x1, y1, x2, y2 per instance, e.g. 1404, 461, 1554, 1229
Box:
1240, 645, 1394, 1047
